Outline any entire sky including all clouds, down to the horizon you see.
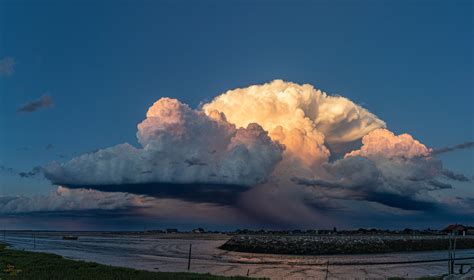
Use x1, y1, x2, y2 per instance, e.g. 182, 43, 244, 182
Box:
0, 0, 474, 229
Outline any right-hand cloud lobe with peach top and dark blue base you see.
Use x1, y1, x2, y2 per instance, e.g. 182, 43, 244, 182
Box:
293, 129, 467, 210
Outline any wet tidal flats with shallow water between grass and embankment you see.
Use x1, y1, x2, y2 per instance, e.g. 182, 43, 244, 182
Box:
0, 232, 474, 279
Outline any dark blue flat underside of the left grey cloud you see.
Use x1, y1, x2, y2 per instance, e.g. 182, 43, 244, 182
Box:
61, 183, 249, 205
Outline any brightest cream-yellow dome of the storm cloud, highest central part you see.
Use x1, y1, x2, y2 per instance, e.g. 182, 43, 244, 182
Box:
203, 80, 385, 173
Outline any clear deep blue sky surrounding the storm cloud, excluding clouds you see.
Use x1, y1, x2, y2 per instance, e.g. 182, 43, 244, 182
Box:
0, 0, 474, 230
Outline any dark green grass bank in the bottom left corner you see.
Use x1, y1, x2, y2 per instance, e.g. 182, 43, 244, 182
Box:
0, 244, 260, 280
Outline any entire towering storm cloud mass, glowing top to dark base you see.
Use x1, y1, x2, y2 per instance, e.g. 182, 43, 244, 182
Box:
35, 80, 468, 222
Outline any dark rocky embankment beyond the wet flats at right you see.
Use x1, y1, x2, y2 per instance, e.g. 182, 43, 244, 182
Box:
220, 235, 474, 255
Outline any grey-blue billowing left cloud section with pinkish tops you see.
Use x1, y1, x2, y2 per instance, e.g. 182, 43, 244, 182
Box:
45, 98, 284, 191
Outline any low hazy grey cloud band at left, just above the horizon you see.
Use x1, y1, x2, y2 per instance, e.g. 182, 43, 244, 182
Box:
0, 186, 252, 225
